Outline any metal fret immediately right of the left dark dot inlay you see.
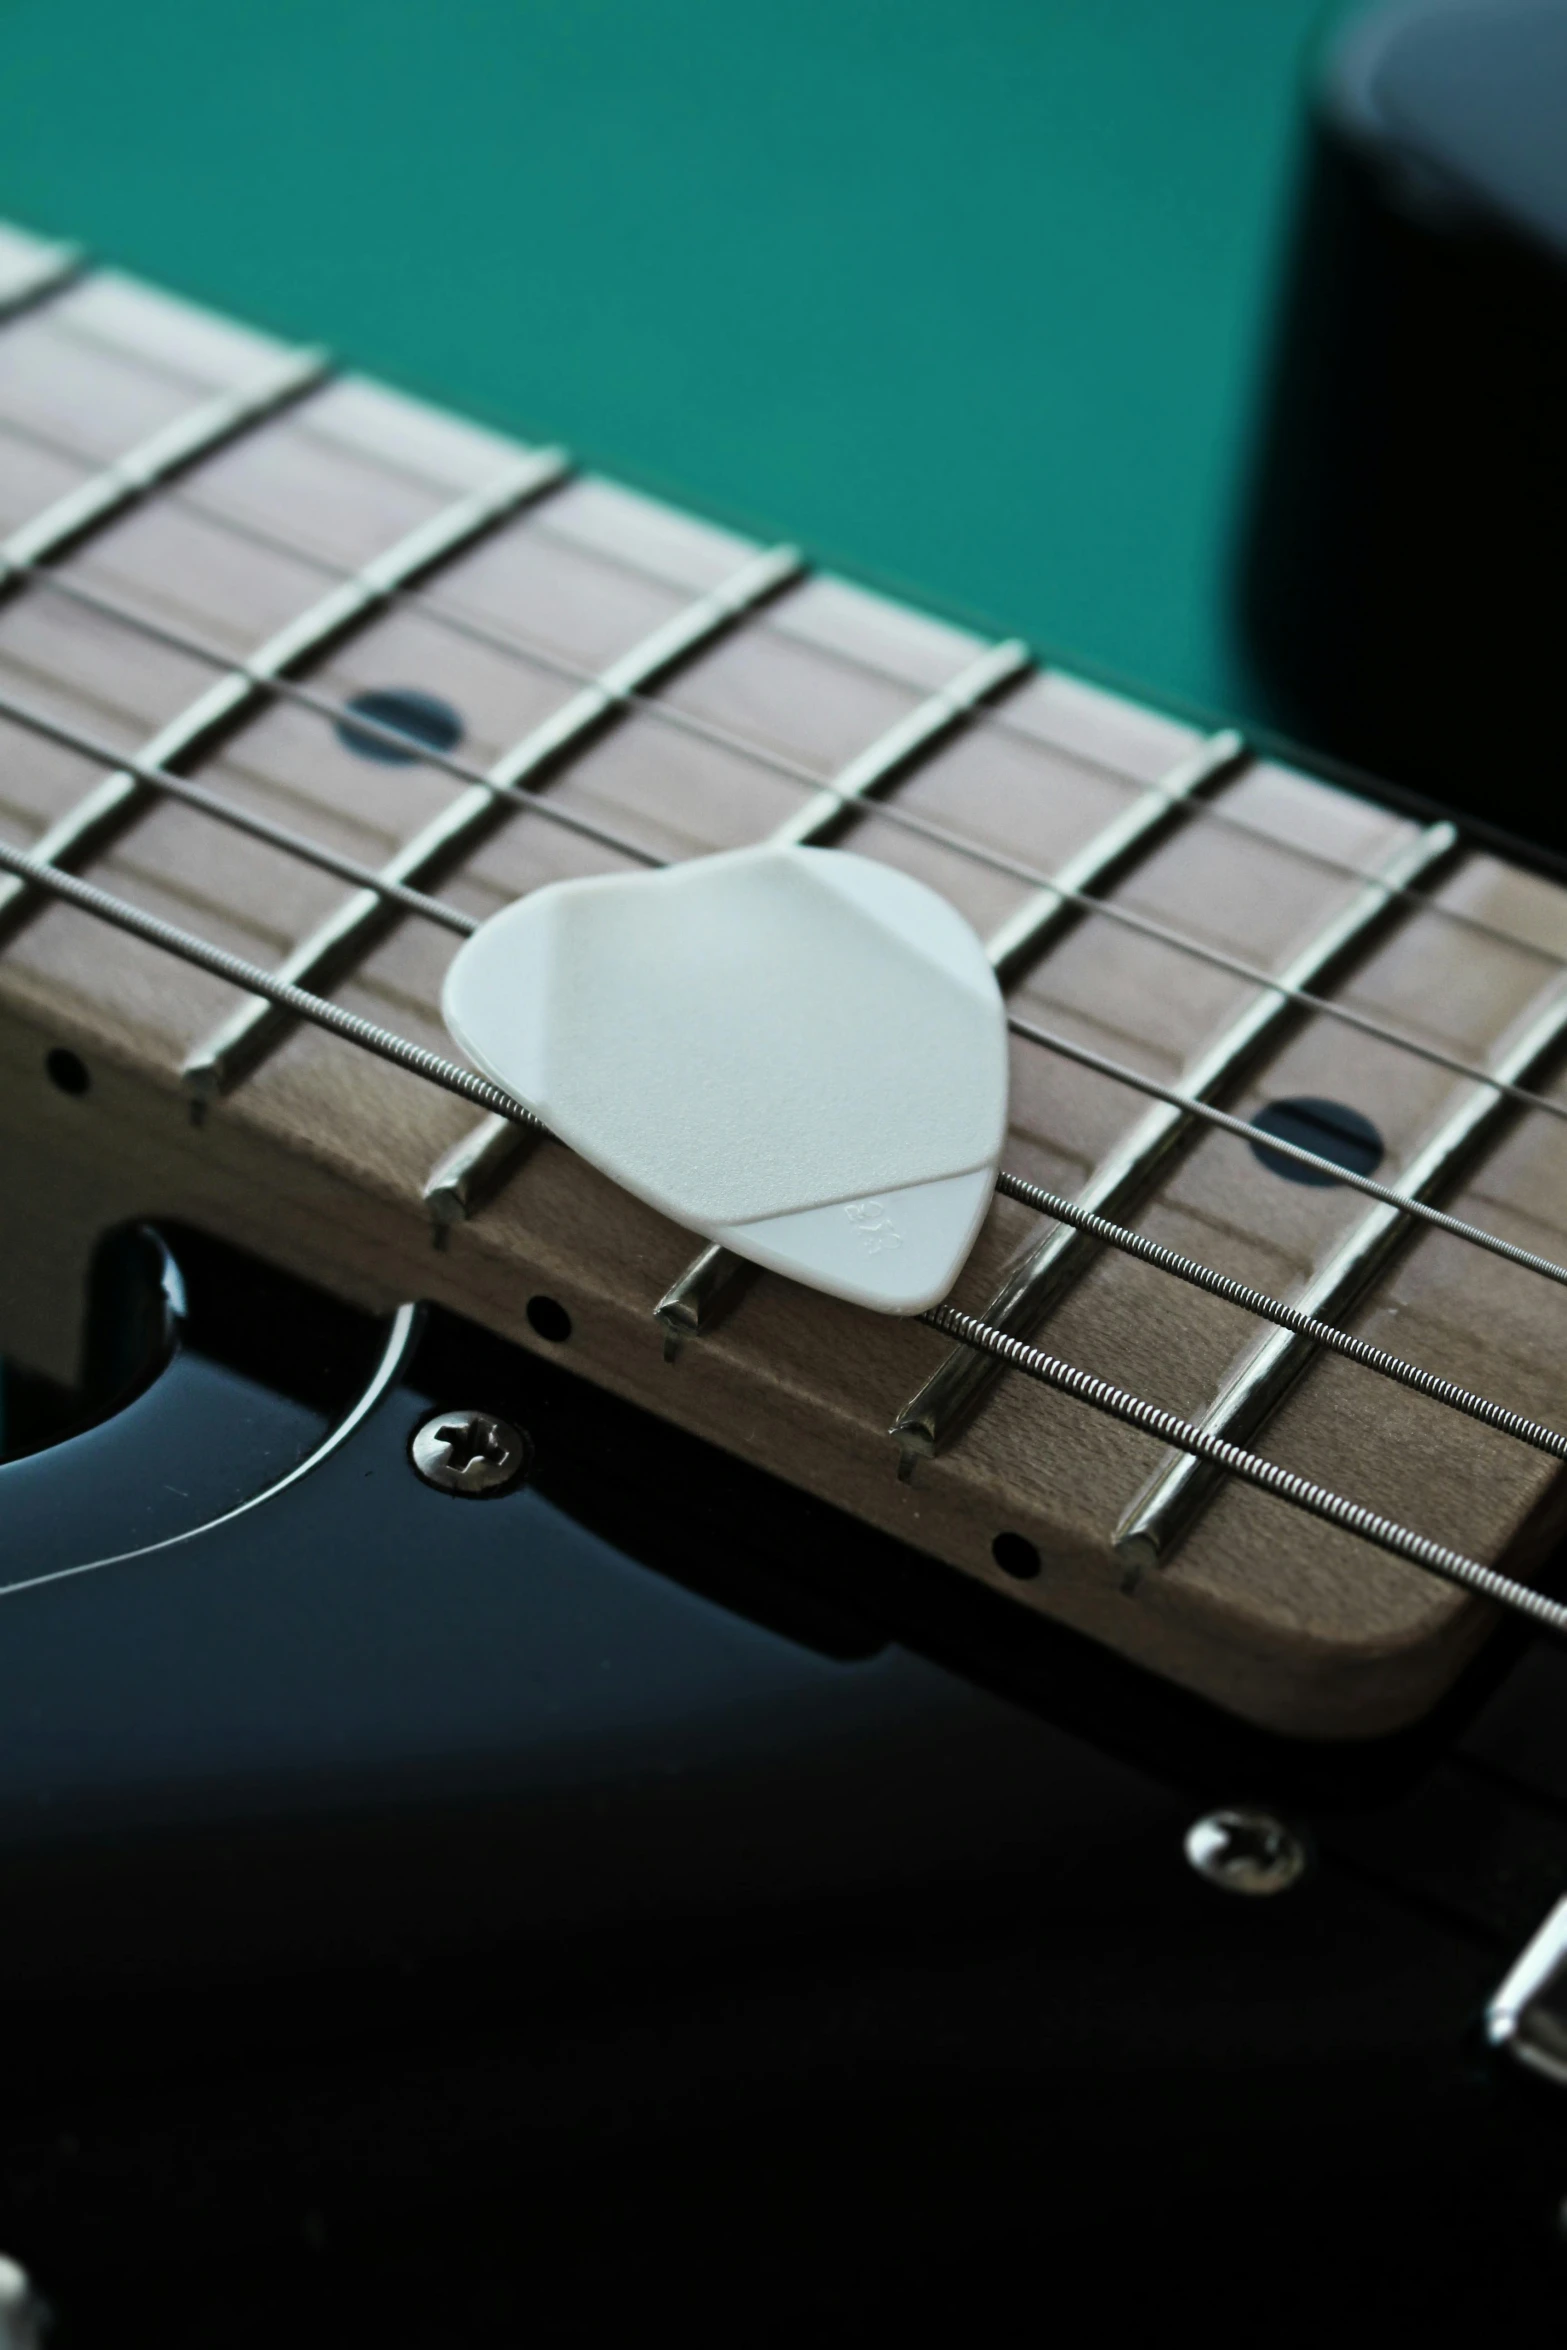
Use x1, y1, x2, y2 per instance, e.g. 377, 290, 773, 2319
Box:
192, 548, 801, 1100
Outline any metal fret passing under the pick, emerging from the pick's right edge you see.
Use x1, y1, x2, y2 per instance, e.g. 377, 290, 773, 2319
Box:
653, 719, 1247, 1363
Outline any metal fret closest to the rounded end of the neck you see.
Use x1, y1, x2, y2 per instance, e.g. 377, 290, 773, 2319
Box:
1116, 987, 1567, 1575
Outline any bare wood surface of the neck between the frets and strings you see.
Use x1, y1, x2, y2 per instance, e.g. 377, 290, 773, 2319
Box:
0, 216, 1567, 1734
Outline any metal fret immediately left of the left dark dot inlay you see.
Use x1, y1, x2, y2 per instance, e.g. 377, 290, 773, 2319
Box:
0, 449, 566, 926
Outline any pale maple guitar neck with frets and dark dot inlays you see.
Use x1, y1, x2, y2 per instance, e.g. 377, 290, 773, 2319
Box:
0, 216, 1567, 1734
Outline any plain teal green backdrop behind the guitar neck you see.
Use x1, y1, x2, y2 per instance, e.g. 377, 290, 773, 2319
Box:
0, 0, 1323, 710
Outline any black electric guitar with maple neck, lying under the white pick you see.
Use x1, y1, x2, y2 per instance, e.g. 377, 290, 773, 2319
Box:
0, 216, 1567, 2341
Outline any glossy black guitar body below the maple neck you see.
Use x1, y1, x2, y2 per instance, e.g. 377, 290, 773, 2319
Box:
0, 1231, 1567, 2350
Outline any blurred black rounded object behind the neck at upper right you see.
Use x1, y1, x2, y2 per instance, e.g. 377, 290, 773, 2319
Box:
1243, 0, 1567, 848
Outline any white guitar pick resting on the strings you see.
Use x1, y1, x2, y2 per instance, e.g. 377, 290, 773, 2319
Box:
442, 846, 1008, 1314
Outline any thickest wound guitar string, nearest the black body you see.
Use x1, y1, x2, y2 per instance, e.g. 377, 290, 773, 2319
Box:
0, 841, 1567, 1633
